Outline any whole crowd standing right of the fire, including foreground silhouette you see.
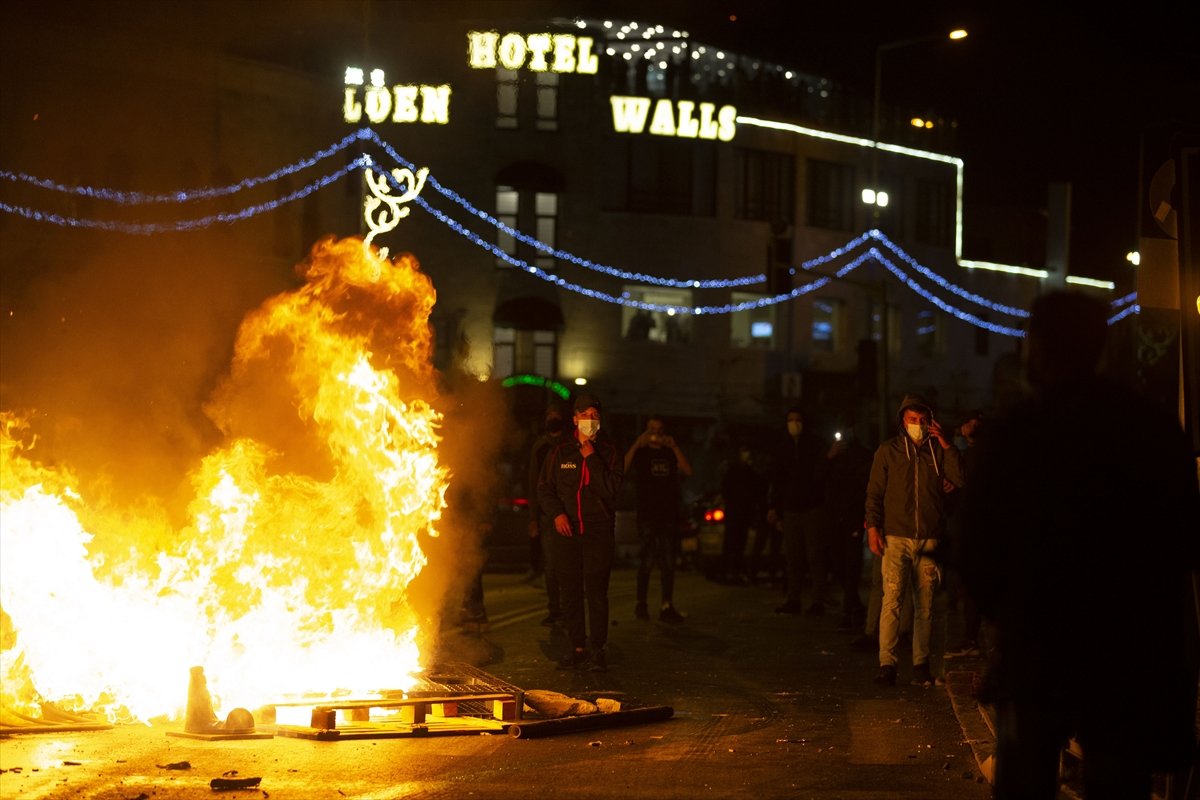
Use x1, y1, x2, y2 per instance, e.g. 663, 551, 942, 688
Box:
518, 291, 1200, 800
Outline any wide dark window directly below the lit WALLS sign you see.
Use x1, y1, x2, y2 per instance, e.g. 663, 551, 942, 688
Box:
604, 136, 716, 216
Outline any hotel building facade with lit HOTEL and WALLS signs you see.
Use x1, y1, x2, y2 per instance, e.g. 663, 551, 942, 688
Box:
0, 4, 1044, 462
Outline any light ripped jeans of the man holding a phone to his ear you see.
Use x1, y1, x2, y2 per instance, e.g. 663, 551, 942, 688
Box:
880, 536, 941, 667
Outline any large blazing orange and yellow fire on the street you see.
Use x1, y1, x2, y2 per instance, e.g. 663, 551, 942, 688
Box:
0, 239, 449, 721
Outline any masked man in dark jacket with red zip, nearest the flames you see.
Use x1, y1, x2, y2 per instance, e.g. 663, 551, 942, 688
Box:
538, 395, 624, 672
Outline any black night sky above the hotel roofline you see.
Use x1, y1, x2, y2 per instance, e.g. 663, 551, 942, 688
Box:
9, 0, 1200, 288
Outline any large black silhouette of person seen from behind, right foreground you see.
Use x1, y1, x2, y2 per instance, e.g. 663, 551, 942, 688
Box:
959, 291, 1200, 800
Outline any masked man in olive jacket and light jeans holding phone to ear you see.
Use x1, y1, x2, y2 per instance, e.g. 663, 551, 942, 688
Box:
866, 395, 964, 686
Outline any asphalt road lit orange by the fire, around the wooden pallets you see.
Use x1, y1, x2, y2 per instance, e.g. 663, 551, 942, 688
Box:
0, 567, 990, 800
